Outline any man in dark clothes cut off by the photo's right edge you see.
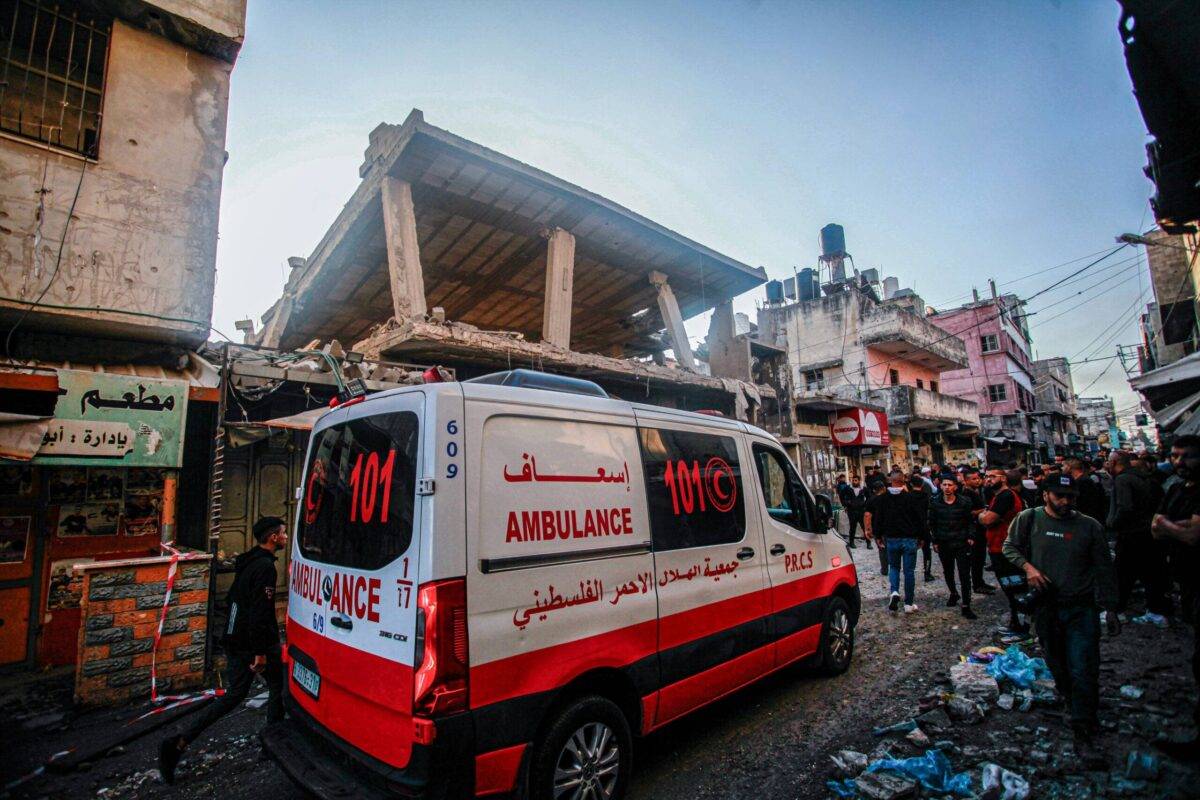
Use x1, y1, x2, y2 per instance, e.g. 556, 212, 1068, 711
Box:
1151, 435, 1200, 760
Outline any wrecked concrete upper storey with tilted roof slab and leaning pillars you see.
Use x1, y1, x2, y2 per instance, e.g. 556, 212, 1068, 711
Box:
247, 109, 774, 421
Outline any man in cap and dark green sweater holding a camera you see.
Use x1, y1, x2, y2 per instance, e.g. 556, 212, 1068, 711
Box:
1004, 475, 1121, 758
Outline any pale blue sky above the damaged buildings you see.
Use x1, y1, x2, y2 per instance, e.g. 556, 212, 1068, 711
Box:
214, 0, 1153, 422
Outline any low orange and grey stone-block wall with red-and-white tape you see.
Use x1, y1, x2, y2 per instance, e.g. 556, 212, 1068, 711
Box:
74, 554, 211, 706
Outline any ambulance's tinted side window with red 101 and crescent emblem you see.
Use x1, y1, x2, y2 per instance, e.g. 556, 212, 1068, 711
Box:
640, 428, 745, 552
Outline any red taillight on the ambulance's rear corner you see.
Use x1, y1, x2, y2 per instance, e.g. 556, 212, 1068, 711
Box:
413, 578, 468, 716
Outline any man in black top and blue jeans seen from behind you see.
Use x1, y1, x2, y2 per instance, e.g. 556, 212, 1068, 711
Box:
866, 467, 929, 614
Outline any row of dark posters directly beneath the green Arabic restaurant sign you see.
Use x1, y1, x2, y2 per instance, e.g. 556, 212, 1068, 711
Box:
47, 467, 168, 537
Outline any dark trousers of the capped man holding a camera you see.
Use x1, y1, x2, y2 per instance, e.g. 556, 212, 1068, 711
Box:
1034, 601, 1100, 730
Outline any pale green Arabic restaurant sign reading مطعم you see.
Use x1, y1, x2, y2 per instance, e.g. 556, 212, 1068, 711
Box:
34, 369, 187, 467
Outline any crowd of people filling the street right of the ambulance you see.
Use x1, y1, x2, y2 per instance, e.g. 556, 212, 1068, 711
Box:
836, 435, 1200, 760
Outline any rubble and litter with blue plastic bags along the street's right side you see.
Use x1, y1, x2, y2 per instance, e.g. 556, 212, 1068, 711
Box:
826, 633, 1195, 800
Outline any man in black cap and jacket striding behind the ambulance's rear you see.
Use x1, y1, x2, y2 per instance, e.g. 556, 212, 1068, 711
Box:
158, 517, 288, 783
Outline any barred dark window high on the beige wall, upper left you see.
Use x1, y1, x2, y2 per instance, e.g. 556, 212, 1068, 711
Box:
0, 0, 112, 157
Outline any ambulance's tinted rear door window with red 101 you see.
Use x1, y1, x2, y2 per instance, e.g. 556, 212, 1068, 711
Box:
300, 411, 419, 570
